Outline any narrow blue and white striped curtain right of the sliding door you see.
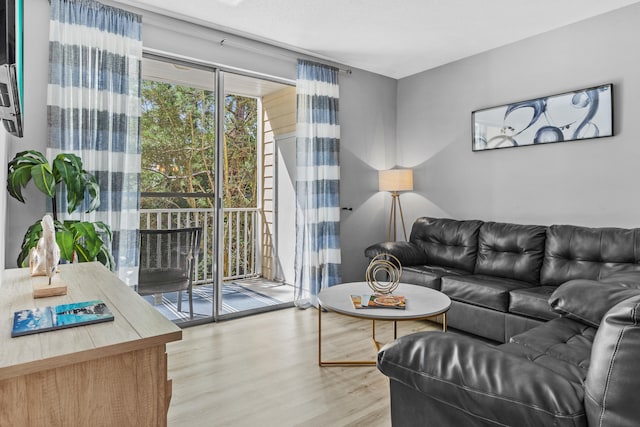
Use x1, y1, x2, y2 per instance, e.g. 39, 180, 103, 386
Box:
295, 60, 340, 308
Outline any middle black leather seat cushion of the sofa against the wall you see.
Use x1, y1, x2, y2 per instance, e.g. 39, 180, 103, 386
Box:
440, 274, 531, 313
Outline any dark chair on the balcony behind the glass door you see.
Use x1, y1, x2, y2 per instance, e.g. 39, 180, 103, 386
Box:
138, 227, 202, 319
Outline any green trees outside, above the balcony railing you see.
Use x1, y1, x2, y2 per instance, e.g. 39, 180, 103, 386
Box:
141, 80, 258, 208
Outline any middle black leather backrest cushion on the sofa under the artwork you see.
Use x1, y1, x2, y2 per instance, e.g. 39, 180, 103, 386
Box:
475, 222, 547, 285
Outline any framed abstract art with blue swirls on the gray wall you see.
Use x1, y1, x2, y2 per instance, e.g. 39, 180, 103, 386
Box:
471, 84, 613, 151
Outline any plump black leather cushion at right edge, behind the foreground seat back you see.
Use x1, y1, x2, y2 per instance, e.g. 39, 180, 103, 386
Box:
549, 279, 640, 328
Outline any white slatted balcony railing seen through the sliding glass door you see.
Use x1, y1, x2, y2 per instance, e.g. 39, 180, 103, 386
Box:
140, 196, 260, 284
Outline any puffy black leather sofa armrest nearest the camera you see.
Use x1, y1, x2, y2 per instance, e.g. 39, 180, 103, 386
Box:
378, 332, 586, 426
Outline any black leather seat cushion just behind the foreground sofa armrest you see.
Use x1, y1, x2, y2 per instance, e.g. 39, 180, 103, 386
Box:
498, 317, 597, 383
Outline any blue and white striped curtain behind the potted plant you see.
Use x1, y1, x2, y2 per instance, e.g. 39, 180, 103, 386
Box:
47, 0, 142, 284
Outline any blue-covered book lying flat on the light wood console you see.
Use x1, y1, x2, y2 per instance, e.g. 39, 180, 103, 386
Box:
11, 300, 113, 337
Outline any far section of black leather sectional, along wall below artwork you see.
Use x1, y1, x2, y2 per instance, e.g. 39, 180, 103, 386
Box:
365, 217, 640, 343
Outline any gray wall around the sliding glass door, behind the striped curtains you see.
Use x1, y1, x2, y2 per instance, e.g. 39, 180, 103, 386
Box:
0, 1, 397, 280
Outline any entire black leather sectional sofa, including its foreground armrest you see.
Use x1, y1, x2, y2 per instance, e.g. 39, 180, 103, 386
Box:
366, 218, 640, 427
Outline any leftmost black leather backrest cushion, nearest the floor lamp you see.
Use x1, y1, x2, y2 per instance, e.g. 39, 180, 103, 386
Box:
409, 217, 482, 272
